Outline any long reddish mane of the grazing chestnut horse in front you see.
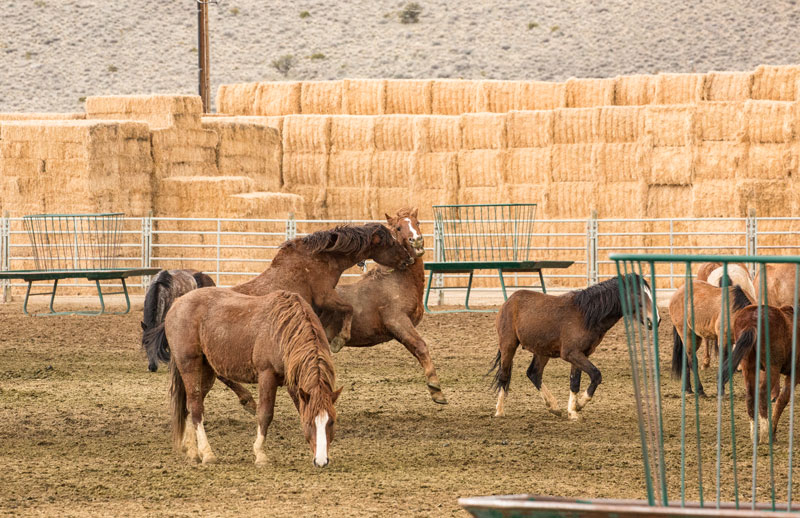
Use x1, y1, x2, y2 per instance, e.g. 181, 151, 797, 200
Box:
269, 290, 336, 413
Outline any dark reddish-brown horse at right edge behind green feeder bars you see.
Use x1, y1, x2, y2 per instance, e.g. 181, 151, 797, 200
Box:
722, 304, 800, 442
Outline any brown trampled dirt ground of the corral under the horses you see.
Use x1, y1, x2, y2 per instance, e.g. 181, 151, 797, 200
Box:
0, 303, 800, 516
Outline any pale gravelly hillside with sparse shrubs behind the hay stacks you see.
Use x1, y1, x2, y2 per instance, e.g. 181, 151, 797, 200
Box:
0, 0, 800, 111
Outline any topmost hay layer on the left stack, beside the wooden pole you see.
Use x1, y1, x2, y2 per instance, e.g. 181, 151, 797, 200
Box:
86, 95, 203, 129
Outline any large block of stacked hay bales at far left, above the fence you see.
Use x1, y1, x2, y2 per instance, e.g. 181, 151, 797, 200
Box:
0, 120, 153, 216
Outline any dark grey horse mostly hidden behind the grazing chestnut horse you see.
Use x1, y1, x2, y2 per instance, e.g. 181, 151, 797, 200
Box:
141, 269, 216, 372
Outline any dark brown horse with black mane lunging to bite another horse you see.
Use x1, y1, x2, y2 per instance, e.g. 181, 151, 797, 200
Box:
147, 223, 414, 413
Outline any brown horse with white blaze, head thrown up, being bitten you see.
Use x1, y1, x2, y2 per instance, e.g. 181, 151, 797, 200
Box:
320, 209, 447, 405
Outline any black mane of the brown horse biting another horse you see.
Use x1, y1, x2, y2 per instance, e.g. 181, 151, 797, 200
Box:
281, 223, 392, 255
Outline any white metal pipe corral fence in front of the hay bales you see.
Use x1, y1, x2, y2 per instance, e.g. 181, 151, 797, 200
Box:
0, 217, 800, 301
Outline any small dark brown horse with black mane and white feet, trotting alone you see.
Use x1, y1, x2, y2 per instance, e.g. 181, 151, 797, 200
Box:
489, 274, 661, 420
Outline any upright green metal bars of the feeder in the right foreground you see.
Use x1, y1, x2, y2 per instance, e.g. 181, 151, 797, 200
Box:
611, 254, 800, 511
